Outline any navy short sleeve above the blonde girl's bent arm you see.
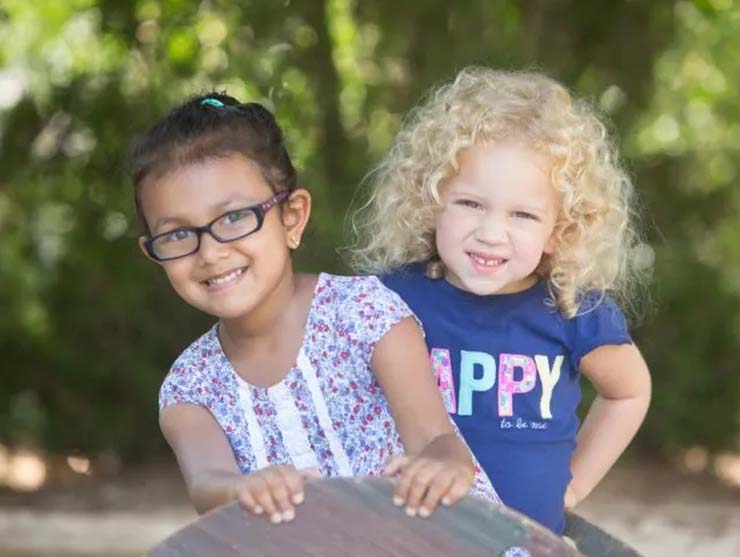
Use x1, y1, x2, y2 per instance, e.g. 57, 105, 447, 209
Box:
571, 296, 632, 369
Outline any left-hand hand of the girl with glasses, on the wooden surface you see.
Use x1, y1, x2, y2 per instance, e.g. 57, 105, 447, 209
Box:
232, 466, 319, 524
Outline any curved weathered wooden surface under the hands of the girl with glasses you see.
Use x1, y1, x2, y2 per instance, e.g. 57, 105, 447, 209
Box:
149, 479, 577, 557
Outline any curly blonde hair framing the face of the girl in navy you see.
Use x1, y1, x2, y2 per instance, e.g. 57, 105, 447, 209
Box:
347, 67, 645, 317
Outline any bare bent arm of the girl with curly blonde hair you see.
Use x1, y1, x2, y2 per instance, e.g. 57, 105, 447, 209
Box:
565, 344, 651, 508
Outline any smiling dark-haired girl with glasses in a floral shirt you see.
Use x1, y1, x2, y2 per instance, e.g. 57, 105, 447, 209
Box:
130, 94, 495, 523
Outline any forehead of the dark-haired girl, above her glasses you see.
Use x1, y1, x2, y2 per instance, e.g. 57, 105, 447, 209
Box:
140, 156, 272, 225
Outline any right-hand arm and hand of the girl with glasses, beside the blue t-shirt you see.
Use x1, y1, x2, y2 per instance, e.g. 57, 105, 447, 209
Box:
371, 317, 475, 516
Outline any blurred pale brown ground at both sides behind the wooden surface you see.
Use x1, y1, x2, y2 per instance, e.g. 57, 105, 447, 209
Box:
0, 461, 740, 557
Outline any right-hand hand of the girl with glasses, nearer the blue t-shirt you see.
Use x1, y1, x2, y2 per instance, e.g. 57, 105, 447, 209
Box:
383, 456, 474, 518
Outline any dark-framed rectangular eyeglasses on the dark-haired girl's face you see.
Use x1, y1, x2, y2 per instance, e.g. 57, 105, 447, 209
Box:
144, 191, 289, 261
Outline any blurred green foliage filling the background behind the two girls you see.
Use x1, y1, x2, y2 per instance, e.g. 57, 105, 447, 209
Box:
0, 0, 740, 459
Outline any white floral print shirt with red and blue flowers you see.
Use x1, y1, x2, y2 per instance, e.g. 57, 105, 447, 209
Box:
159, 274, 496, 500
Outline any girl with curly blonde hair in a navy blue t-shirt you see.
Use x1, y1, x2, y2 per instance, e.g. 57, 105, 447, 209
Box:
350, 68, 650, 533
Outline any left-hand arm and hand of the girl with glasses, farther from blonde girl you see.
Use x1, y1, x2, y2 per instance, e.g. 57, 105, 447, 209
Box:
159, 404, 312, 523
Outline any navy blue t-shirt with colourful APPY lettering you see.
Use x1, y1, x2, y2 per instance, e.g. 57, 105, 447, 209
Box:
381, 264, 632, 534
